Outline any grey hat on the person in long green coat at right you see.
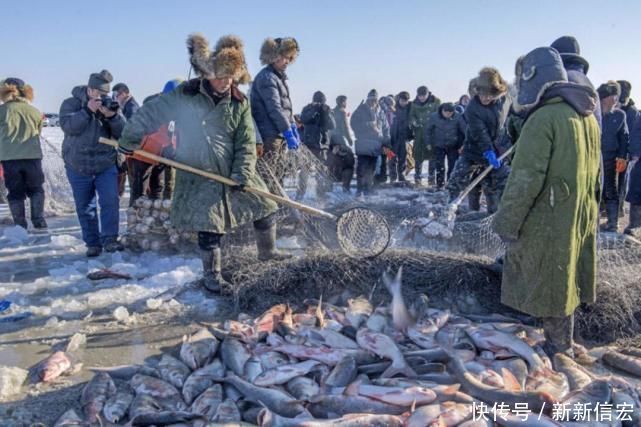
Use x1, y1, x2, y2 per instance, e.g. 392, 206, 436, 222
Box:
513, 47, 568, 112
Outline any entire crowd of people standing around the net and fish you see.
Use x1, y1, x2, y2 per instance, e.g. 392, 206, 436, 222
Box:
0, 34, 641, 353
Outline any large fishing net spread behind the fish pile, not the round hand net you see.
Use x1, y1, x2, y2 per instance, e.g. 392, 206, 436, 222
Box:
37, 130, 641, 342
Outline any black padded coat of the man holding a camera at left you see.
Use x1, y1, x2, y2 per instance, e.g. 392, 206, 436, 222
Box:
60, 86, 125, 176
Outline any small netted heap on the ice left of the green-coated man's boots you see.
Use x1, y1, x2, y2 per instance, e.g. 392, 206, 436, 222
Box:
120, 196, 192, 251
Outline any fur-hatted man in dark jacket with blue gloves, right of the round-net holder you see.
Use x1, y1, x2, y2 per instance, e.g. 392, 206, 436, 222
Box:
250, 37, 300, 166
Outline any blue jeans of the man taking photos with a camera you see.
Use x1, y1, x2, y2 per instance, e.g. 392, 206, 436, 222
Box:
66, 165, 120, 247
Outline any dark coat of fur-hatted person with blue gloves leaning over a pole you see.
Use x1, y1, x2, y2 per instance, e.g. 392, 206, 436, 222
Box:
463, 96, 510, 163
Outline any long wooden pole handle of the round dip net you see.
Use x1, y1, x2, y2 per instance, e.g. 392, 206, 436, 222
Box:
98, 138, 338, 221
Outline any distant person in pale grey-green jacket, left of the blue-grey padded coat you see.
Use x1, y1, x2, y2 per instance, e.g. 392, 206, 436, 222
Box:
327, 95, 355, 193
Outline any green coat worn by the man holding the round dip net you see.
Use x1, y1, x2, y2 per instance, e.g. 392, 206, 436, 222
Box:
119, 79, 277, 233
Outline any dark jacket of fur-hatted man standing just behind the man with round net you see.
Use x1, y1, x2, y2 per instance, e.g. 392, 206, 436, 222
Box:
250, 65, 294, 139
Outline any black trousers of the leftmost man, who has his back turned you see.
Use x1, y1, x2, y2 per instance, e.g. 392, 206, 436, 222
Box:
2, 159, 45, 202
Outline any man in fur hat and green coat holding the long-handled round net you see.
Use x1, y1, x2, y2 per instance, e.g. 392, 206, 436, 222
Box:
119, 34, 286, 292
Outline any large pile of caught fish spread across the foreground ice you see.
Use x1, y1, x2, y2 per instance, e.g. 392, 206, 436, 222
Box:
51, 271, 641, 427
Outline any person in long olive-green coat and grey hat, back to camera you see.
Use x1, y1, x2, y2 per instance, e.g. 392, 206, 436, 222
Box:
494, 47, 601, 356
